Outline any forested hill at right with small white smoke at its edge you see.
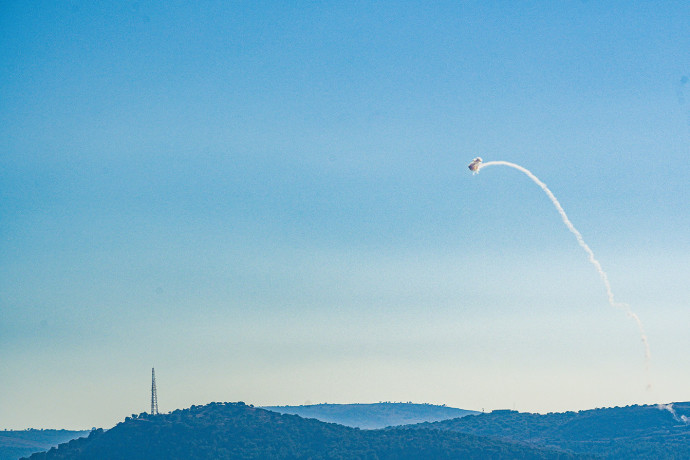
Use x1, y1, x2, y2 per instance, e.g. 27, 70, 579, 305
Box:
408, 402, 690, 459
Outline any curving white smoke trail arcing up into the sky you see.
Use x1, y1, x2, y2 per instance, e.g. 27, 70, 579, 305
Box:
469, 157, 652, 389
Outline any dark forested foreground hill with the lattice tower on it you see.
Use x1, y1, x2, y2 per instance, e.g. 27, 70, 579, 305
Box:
24, 403, 581, 460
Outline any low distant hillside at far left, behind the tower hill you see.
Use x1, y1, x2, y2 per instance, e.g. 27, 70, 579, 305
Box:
0, 430, 89, 460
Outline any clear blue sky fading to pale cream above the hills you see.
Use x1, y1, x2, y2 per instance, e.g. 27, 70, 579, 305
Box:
0, 1, 690, 429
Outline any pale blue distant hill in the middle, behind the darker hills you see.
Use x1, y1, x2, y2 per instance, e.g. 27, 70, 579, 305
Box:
263, 402, 478, 429
